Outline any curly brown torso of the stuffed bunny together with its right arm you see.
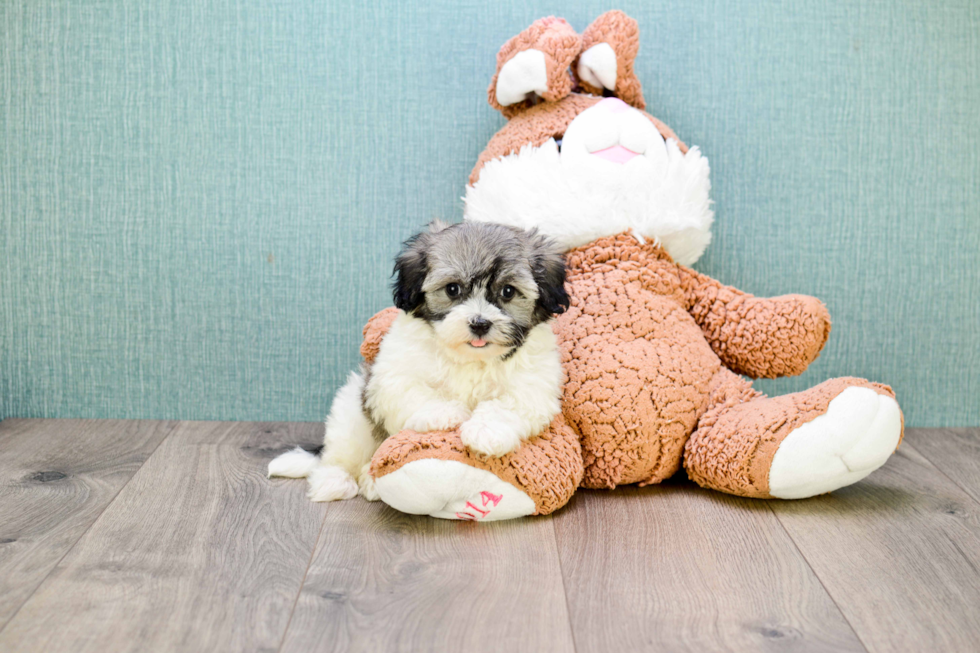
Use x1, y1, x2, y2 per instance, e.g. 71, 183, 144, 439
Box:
557, 234, 829, 488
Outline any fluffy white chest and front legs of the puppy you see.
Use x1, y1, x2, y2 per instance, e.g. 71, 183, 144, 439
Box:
364, 313, 564, 439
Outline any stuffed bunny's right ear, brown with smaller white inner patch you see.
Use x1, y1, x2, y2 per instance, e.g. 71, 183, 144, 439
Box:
572, 11, 646, 109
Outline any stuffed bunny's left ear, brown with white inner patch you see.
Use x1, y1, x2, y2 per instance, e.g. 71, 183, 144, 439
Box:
487, 16, 582, 119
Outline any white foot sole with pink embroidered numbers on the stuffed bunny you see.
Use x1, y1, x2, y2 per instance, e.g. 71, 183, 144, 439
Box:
374, 458, 535, 521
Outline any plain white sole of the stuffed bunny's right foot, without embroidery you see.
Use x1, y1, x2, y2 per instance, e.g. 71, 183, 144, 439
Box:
769, 387, 902, 499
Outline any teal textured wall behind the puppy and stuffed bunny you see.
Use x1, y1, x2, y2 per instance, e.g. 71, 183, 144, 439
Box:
0, 0, 980, 426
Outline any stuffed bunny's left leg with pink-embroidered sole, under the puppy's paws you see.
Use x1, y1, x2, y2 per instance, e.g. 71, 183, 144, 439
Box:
371, 416, 582, 521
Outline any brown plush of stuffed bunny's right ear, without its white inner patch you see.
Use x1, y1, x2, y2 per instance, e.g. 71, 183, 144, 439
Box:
572, 10, 647, 109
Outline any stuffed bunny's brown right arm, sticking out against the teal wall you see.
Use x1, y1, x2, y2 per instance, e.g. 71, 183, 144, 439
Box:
677, 265, 830, 379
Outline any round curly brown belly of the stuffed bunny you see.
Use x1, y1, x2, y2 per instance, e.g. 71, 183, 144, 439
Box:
556, 283, 721, 488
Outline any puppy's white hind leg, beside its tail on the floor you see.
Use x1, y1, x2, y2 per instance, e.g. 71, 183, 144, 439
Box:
307, 372, 379, 501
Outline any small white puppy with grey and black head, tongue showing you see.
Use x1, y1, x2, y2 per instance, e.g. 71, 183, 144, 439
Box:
269, 221, 568, 501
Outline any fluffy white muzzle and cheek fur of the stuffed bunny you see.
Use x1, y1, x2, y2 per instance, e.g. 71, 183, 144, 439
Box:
464, 103, 714, 265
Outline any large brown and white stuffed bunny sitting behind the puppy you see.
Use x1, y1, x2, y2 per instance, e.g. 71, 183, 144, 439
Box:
361, 11, 903, 520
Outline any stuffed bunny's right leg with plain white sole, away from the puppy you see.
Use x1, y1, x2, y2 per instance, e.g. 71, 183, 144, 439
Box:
684, 369, 903, 499
